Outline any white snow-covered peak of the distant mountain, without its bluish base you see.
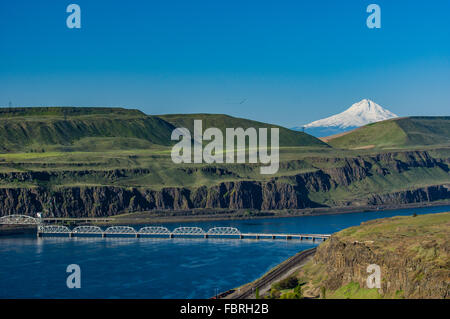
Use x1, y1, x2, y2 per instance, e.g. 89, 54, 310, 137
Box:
304, 99, 397, 129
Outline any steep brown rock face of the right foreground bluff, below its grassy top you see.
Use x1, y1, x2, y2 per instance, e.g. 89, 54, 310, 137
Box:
315, 238, 449, 298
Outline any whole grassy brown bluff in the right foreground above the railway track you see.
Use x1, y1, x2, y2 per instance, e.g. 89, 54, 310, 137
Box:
310, 213, 450, 298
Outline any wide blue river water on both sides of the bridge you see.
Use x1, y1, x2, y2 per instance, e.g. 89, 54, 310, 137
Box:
0, 206, 450, 298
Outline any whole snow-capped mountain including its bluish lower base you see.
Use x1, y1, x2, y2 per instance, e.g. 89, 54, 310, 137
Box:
295, 99, 397, 136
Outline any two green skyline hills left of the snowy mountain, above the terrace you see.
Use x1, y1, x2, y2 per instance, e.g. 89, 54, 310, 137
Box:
0, 107, 328, 153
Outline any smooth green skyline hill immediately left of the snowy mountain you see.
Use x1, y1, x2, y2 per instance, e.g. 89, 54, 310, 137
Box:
159, 114, 329, 147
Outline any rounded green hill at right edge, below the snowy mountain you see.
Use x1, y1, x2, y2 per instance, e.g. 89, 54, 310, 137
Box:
328, 116, 450, 149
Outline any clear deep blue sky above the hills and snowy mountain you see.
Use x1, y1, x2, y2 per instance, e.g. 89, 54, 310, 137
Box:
0, 0, 450, 127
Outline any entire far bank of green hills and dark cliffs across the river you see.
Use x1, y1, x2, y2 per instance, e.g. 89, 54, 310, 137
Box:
0, 108, 450, 216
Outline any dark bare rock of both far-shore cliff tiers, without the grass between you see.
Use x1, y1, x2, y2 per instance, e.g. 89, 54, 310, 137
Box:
0, 152, 450, 217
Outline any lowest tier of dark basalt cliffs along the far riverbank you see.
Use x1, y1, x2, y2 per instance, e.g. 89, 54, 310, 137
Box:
0, 182, 450, 217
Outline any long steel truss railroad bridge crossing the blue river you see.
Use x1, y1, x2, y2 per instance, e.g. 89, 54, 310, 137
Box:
0, 215, 330, 241
